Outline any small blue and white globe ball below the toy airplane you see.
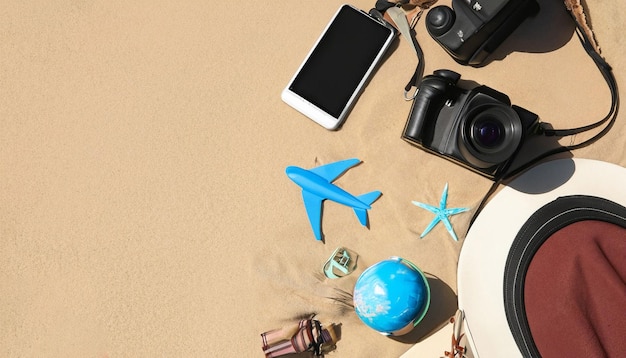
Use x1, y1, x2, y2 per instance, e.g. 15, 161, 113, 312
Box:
354, 257, 430, 335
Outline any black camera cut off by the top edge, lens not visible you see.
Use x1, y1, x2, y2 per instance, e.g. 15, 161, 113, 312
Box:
426, 0, 539, 66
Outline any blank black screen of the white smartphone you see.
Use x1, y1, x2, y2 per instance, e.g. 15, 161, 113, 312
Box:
289, 5, 391, 118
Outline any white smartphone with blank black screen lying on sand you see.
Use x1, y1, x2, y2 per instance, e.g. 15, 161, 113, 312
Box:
281, 4, 396, 130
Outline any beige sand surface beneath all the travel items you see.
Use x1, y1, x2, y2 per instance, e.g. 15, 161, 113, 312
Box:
0, 0, 626, 357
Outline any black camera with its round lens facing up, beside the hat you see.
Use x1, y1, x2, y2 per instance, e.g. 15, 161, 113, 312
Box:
402, 70, 539, 179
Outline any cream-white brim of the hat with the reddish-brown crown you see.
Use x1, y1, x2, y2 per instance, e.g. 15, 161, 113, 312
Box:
457, 159, 626, 357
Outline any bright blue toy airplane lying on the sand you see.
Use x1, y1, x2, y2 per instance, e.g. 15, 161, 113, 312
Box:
285, 158, 381, 240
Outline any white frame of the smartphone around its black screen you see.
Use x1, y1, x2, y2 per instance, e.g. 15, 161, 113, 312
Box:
280, 4, 396, 130
